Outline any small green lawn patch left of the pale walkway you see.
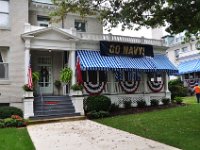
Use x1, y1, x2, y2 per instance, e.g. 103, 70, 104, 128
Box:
0, 128, 35, 150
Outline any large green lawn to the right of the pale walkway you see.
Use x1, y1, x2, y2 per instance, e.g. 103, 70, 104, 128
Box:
96, 97, 200, 150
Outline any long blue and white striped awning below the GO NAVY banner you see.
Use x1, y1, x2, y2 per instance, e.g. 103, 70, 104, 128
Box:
77, 50, 178, 73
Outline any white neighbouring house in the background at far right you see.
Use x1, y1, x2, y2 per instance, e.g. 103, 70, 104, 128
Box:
163, 32, 200, 88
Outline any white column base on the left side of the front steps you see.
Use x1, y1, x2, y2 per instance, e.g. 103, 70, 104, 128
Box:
24, 98, 34, 119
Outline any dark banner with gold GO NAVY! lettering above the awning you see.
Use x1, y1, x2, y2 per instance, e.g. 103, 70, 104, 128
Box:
100, 41, 154, 57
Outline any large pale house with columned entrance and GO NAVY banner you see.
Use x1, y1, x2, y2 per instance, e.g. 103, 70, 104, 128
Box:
0, 0, 177, 118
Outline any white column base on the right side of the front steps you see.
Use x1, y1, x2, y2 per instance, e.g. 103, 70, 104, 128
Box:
71, 97, 85, 115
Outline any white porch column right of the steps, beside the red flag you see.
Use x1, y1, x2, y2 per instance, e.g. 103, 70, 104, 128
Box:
69, 50, 76, 85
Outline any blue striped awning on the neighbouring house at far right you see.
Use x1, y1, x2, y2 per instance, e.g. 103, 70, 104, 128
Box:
178, 59, 200, 74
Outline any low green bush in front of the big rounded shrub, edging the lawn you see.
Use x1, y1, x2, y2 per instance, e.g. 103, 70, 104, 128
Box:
87, 110, 110, 119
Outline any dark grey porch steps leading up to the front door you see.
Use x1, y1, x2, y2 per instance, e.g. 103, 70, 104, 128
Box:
34, 96, 80, 117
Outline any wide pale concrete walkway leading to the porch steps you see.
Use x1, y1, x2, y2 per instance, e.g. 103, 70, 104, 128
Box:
28, 120, 178, 150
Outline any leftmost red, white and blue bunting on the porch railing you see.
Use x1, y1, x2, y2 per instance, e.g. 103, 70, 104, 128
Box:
83, 82, 106, 95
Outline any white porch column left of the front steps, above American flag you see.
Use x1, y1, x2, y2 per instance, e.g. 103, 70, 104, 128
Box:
24, 38, 31, 84
